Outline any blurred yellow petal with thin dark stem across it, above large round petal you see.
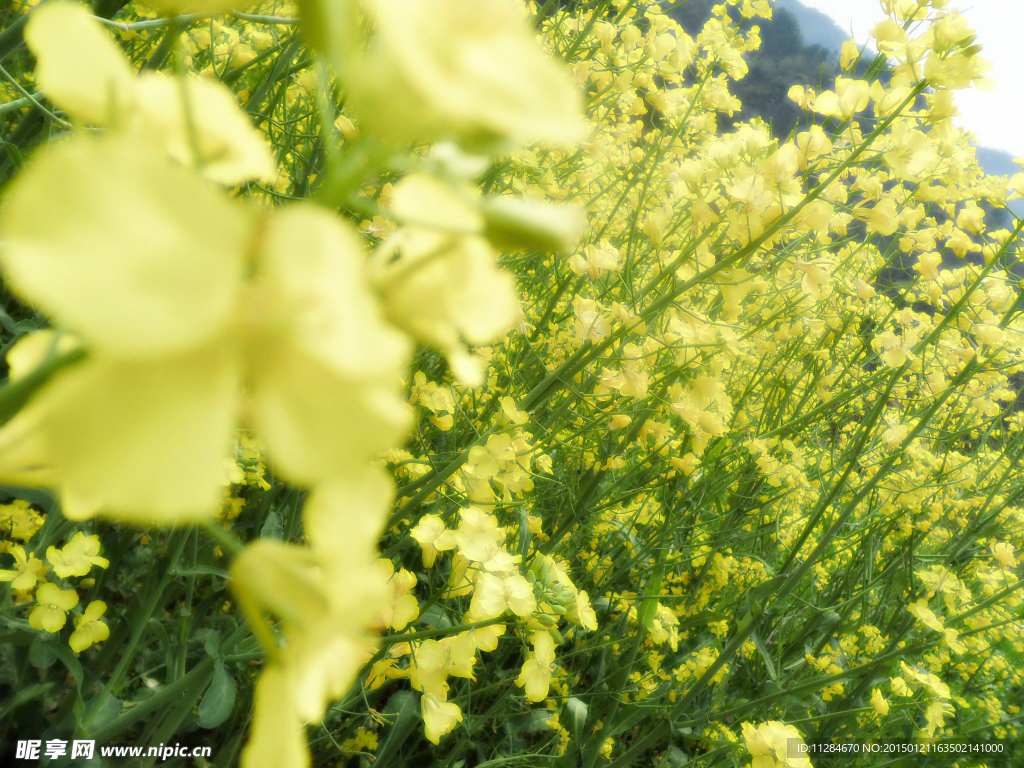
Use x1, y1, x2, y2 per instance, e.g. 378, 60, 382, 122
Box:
138, 73, 276, 186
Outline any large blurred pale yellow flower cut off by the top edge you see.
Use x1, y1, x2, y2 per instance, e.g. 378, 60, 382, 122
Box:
341, 0, 586, 152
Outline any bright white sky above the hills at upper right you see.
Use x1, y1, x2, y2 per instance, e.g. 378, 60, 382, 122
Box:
801, 0, 1024, 158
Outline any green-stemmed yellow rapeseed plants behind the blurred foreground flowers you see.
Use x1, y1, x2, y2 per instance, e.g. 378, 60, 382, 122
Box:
0, 0, 1024, 768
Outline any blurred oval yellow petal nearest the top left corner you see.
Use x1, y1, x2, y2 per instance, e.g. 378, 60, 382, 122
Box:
25, 2, 135, 125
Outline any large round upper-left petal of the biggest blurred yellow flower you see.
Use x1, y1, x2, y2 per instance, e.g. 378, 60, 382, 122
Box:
0, 137, 251, 355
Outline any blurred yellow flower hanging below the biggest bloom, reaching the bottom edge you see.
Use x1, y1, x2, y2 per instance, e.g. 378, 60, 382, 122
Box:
231, 481, 391, 768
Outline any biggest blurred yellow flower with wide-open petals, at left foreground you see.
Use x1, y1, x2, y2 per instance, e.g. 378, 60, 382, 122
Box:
0, 136, 409, 523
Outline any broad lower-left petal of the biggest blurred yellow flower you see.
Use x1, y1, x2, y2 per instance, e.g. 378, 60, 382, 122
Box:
0, 347, 238, 524
